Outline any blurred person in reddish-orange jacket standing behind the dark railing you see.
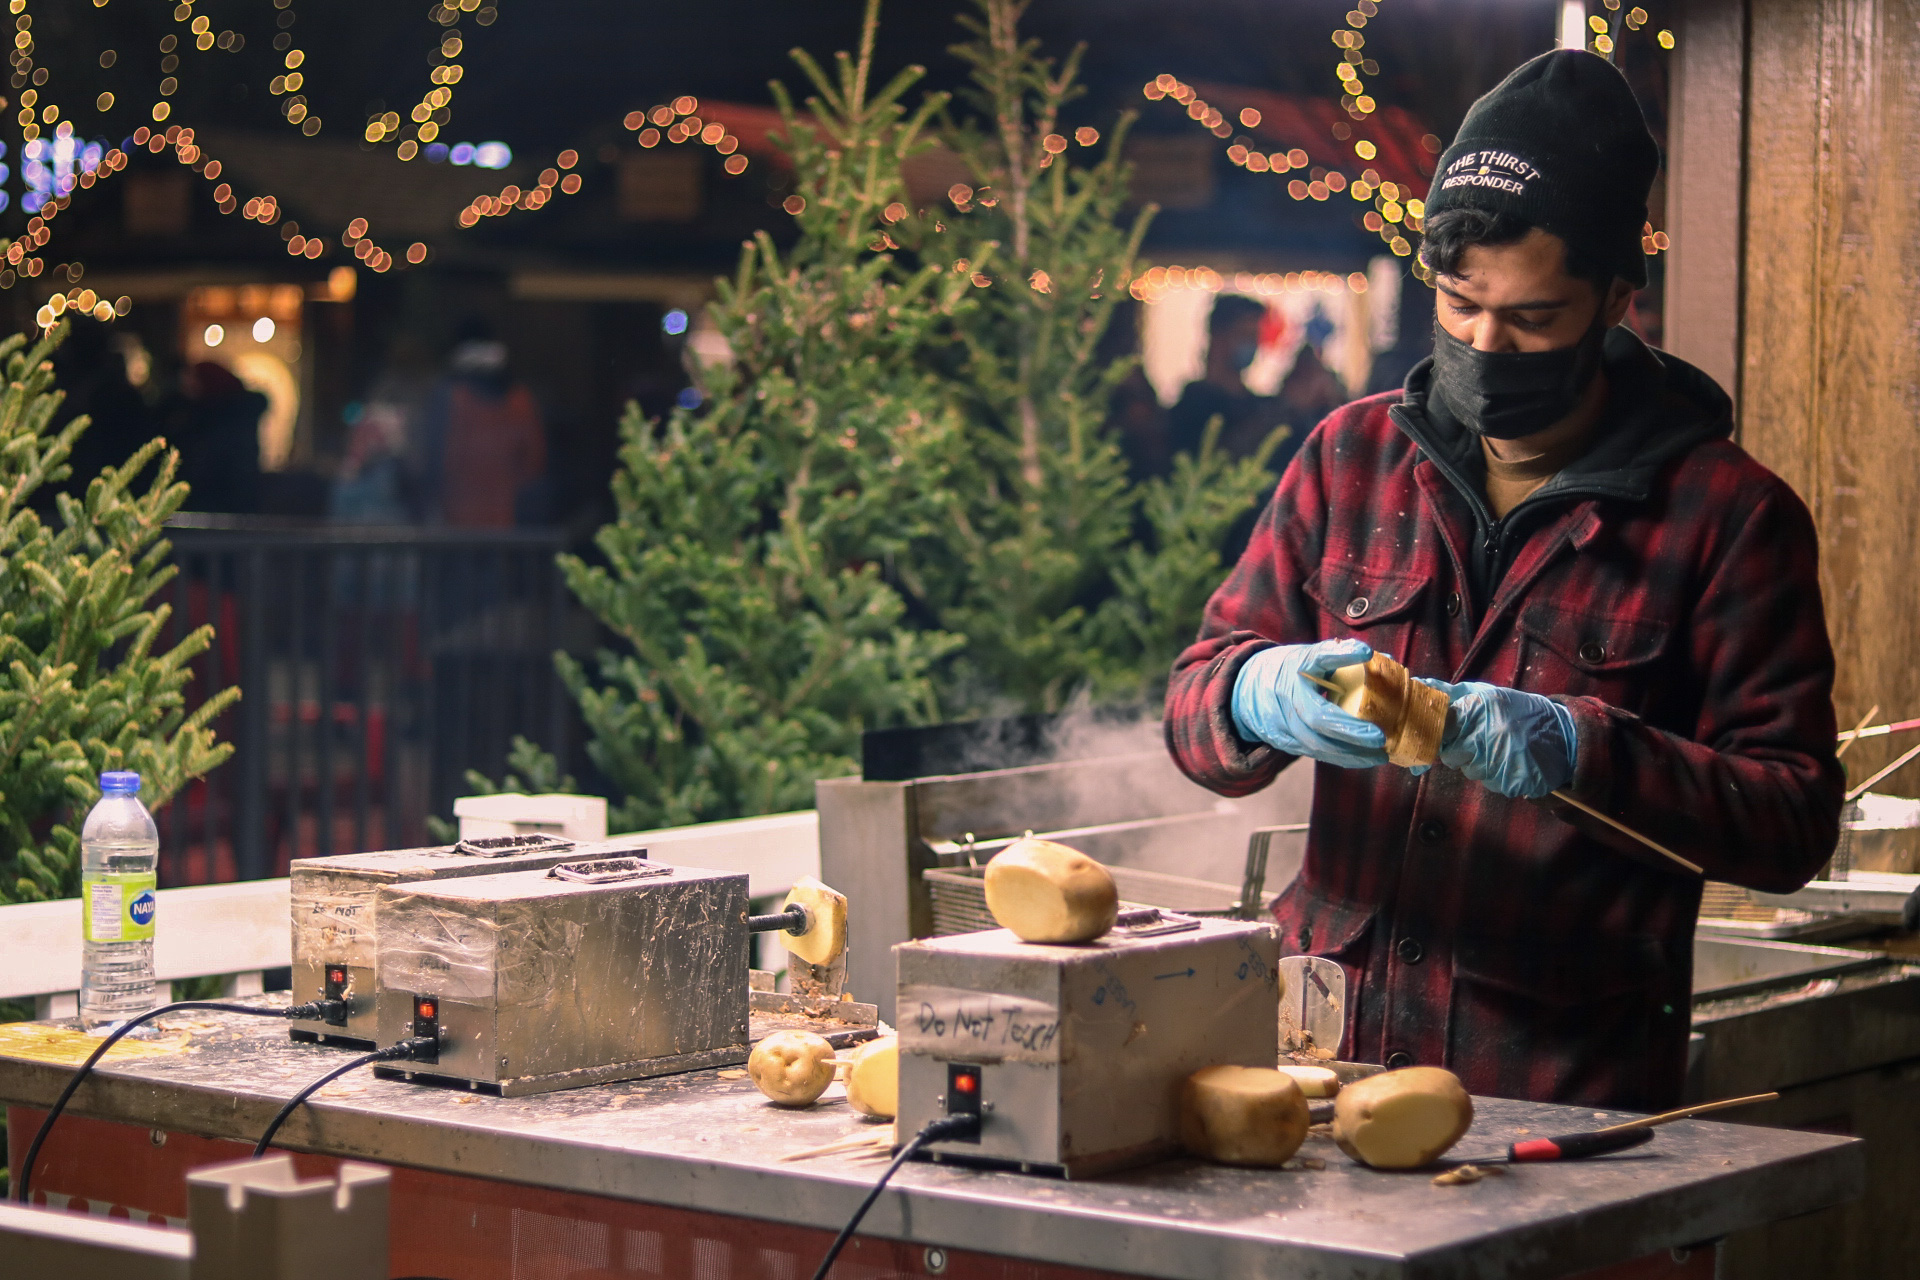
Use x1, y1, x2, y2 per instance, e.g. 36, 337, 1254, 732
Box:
420, 320, 547, 530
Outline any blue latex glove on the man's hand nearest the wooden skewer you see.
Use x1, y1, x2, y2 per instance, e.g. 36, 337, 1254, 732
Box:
1419, 677, 1576, 800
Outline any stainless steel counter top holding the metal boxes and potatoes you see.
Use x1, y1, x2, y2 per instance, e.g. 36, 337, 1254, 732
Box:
0, 1015, 1864, 1280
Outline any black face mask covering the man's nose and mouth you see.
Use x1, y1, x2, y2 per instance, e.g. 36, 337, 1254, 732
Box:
1434, 313, 1607, 439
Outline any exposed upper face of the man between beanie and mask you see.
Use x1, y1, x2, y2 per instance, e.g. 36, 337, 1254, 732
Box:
1434, 226, 1634, 351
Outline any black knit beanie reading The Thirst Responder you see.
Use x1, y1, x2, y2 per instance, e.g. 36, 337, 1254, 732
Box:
1425, 48, 1661, 288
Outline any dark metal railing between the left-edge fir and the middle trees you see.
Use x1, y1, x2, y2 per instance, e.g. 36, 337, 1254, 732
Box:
156, 514, 578, 885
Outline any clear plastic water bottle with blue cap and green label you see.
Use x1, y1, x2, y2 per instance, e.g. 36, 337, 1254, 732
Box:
81, 773, 159, 1031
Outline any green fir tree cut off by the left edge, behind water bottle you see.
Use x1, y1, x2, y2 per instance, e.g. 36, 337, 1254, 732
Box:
0, 324, 240, 904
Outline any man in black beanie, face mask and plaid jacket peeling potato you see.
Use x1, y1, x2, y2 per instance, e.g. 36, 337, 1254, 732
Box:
1167, 50, 1841, 1109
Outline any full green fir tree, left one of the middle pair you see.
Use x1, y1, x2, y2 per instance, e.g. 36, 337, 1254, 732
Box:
561, 0, 972, 829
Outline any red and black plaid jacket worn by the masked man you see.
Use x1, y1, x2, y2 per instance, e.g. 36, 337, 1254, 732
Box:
1165, 334, 1843, 1109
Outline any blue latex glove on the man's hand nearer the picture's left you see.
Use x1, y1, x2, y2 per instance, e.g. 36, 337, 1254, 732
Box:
1233, 639, 1386, 770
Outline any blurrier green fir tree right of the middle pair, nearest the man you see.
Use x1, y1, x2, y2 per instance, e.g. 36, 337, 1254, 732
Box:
927, 0, 1273, 710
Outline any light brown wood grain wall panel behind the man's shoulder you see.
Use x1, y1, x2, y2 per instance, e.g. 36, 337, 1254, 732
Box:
1741, 0, 1920, 794
